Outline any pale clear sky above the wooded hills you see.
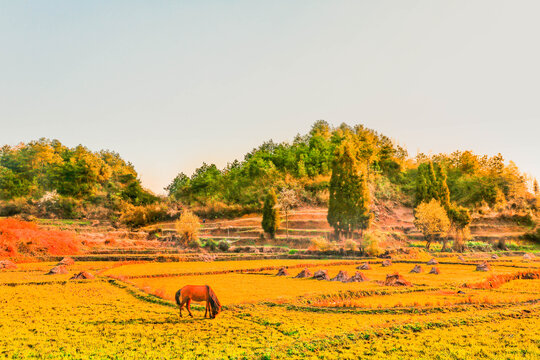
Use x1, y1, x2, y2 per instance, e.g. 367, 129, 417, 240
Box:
0, 0, 540, 193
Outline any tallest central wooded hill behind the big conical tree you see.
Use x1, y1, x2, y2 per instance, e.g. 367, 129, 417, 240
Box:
165, 120, 406, 210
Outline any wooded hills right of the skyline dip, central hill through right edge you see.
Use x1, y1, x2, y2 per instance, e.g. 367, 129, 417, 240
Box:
166, 121, 532, 214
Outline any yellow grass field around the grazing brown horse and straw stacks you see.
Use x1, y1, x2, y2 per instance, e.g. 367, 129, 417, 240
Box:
0, 258, 540, 359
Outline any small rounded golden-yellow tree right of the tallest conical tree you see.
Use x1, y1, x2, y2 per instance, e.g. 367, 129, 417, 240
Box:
414, 199, 450, 250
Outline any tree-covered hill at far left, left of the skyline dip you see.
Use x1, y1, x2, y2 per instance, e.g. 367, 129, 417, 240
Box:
0, 139, 158, 217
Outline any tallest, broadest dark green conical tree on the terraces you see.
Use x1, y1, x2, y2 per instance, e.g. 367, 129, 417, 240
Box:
327, 140, 372, 238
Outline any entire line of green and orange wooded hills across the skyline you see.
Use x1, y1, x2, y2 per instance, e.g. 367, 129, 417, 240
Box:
0, 120, 538, 226
